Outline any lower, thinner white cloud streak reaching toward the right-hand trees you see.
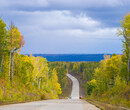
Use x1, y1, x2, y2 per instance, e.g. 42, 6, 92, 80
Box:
61, 28, 118, 40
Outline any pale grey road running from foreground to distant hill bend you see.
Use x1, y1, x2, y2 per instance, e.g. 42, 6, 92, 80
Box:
0, 74, 100, 110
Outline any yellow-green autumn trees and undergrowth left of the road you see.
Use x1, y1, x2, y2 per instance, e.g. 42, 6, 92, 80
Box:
0, 18, 62, 103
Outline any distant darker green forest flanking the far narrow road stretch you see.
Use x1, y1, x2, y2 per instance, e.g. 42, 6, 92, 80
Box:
48, 62, 100, 98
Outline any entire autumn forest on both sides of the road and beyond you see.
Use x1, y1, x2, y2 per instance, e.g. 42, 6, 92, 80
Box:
0, 14, 130, 107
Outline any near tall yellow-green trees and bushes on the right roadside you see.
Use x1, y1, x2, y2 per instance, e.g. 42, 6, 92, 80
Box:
87, 14, 130, 107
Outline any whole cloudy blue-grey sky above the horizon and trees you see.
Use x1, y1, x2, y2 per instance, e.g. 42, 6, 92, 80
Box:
0, 0, 130, 54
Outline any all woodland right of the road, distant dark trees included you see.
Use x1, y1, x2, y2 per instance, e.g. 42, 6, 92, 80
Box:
68, 14, 130, 107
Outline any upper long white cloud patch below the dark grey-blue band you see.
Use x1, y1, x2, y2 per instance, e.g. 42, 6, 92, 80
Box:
9, 11, 101, 31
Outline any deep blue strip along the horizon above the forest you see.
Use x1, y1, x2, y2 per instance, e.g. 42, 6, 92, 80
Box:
33, 54, 111, 62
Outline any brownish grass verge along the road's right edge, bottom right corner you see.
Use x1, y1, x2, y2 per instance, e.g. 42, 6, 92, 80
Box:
85, 99, 130, 110
